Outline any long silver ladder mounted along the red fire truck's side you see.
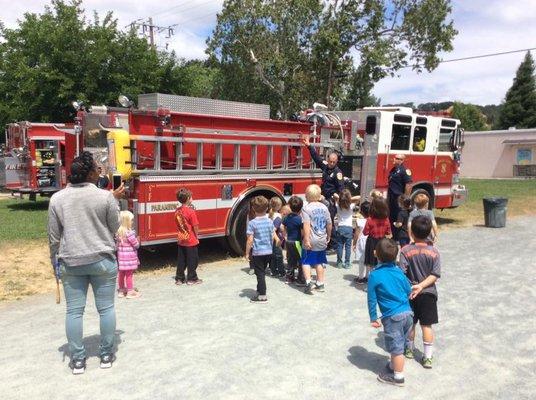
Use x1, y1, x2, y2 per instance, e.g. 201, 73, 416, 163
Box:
129, 131, 334, 175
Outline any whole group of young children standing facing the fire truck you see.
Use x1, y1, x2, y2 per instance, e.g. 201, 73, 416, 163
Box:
112, 184, 441, 386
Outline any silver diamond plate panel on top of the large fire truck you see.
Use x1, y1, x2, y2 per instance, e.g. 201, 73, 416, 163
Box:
138, 93, 270, 119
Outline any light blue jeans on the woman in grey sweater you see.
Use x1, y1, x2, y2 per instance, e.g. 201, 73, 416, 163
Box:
60, 258, 117, 360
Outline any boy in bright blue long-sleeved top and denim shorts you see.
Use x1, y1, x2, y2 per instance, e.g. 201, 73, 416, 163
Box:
367, 239, 413, 386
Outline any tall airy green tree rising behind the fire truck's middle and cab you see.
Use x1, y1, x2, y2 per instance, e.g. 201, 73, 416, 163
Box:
207, 0, 457, 115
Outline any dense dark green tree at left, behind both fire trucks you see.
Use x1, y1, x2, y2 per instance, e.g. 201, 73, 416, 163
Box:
0, 0, 216, 130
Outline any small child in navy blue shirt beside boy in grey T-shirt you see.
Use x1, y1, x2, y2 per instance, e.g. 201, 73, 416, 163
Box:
283, 196, 305, 286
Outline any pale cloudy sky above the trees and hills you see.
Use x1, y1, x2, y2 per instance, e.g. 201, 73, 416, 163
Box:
0, 0, 536, 105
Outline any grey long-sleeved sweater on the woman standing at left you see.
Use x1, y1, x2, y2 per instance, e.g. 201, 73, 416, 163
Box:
48, 183, 119, 266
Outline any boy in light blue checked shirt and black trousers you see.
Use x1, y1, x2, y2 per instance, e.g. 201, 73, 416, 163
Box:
245, 196, 279, 303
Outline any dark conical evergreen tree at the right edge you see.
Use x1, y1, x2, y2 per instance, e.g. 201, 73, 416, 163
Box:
498, 52, 536, 129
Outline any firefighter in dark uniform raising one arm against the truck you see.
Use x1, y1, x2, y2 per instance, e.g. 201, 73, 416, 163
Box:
302, 136, 344, 247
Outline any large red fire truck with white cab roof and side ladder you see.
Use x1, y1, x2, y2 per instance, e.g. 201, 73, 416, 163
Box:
66, 94, 467, 254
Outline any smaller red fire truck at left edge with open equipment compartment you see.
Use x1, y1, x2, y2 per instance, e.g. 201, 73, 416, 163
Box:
0, 121, 72, 200
